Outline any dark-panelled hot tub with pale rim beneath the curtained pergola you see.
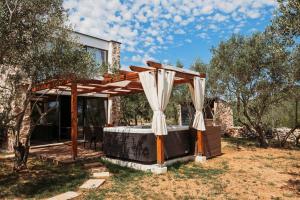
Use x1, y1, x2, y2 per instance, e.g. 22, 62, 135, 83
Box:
103, 126, 195, 164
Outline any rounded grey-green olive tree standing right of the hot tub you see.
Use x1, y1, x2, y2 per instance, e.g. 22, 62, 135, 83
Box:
209, 33, 294, 145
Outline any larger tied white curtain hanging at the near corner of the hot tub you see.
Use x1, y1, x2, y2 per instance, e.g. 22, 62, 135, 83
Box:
139, 69, 175, 135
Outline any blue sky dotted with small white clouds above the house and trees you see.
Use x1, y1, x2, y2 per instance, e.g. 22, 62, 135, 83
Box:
64, 0, 277, 68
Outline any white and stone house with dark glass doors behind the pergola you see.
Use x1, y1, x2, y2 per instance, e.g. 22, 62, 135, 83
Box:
0, 32, 121, 151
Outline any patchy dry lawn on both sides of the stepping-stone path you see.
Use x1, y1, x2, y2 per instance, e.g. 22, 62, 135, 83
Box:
0, 139, 300, 200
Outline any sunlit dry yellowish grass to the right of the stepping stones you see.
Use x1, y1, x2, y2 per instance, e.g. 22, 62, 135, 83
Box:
81, 140, 300, 200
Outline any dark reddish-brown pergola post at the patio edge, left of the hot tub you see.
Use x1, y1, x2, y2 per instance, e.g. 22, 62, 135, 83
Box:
71, 82, 78, 160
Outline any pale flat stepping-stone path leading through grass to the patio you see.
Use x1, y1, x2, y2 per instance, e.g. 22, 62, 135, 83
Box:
48, 162, 110, 200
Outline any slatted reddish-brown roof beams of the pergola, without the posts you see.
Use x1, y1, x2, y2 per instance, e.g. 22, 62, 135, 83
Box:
32, 61, 205, 96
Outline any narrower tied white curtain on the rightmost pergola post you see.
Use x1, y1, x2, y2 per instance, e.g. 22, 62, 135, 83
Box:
189, 77, 205, 131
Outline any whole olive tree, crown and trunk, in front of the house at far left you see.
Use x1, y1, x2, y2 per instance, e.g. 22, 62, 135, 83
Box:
0, 0, 96, 169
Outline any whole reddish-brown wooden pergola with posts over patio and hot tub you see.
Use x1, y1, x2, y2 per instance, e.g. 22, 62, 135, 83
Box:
32, 61, 206, 164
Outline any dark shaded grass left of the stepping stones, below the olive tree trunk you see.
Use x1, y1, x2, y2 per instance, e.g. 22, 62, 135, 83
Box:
0, 159, 88, 199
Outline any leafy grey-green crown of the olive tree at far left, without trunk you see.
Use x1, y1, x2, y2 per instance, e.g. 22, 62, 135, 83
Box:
0, 0, 95, 81
